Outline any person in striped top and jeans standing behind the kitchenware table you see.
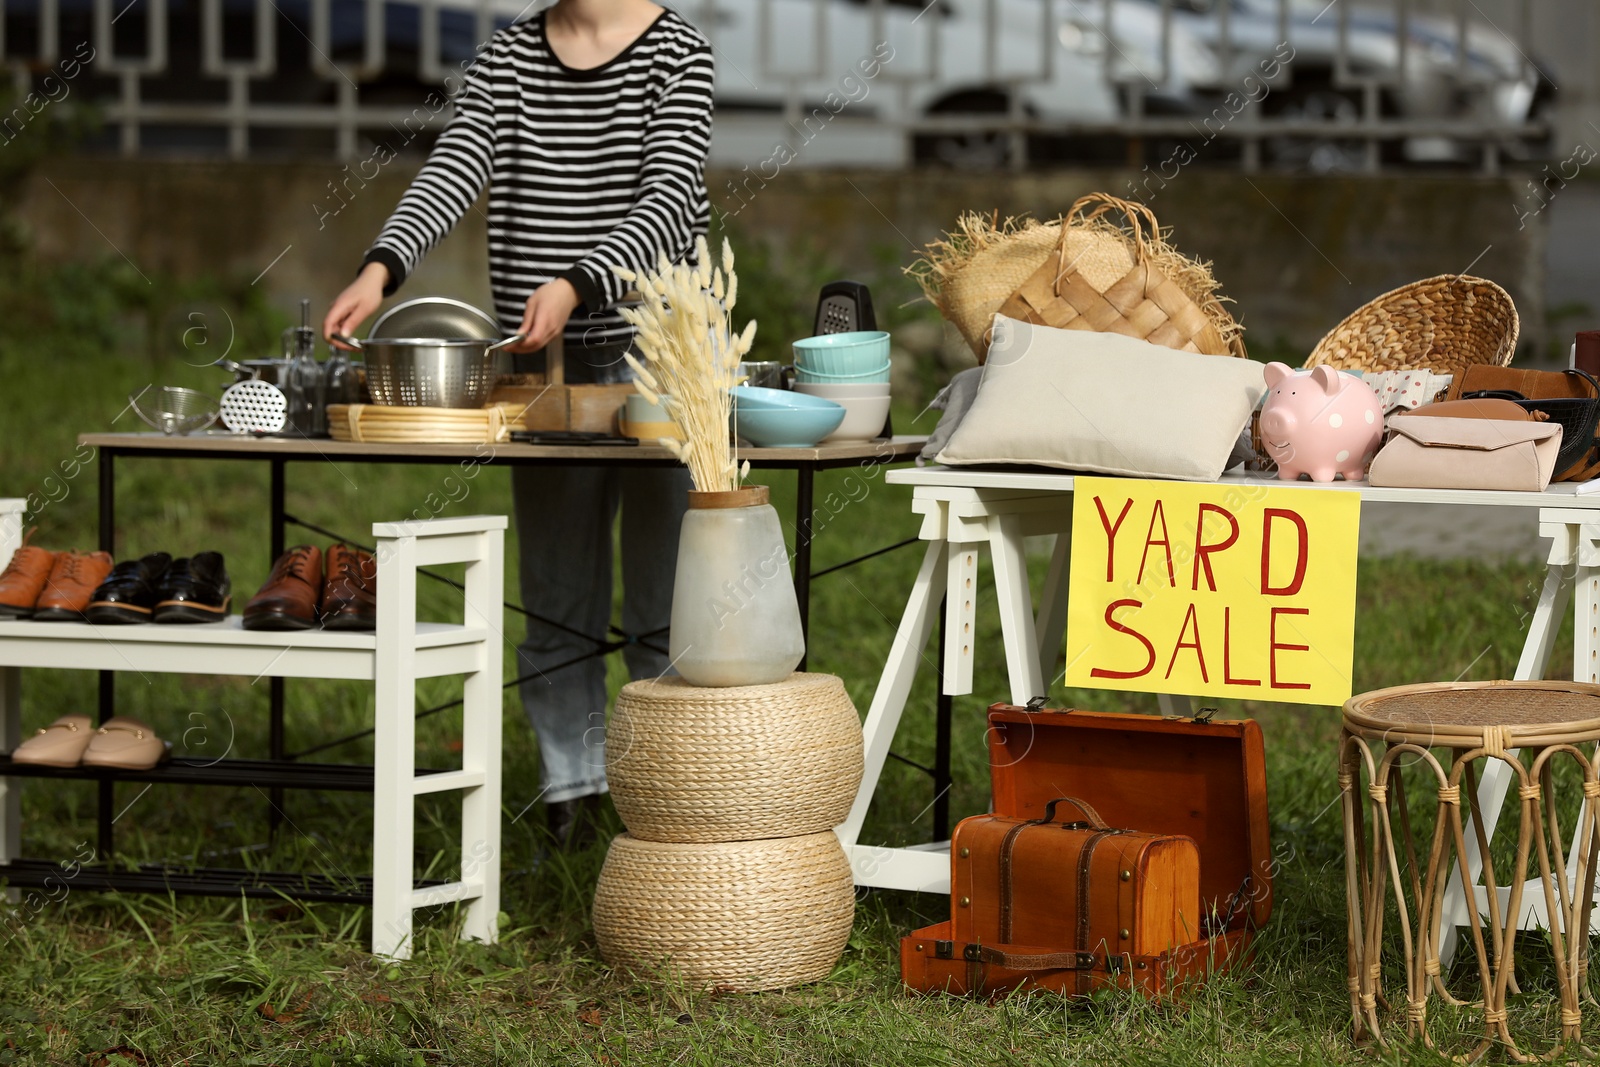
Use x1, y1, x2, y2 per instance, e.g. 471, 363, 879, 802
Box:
323, 0, 712, 845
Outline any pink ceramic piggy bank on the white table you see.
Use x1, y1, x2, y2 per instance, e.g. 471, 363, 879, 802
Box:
1261, 363, 1384, 482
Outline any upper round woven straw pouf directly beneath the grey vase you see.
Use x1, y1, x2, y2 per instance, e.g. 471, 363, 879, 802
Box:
606, 673, 861, 841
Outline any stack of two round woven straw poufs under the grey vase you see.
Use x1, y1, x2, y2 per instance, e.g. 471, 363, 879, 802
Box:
594, 673, 862, 992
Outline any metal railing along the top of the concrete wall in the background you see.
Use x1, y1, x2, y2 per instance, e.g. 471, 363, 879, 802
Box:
0, 0, 1555, 174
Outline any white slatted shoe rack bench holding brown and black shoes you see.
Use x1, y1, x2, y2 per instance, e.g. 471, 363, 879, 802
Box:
0, 499, 507, 960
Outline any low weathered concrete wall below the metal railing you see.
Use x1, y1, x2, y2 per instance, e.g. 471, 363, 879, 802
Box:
14, 158, 1549, 352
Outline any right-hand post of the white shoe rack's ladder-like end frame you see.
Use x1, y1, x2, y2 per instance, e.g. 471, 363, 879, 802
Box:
461, 530, 506, 944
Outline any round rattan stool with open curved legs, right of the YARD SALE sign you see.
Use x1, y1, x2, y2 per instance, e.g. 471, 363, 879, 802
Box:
1339, 681, 1600, 1062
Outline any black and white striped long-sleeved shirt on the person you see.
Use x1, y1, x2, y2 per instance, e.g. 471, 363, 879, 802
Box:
363, 11, 712, 346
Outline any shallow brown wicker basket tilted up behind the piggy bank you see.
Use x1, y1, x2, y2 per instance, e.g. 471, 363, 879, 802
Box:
1306, 274, 1522, 374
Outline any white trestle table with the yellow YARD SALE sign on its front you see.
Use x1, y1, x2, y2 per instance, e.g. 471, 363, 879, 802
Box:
838, 467, 1600, 960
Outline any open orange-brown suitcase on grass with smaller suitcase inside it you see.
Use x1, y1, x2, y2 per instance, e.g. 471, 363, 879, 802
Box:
901, 702, 1272, 995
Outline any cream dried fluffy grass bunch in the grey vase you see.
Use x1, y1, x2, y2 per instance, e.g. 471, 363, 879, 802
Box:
616, 237, 755, 493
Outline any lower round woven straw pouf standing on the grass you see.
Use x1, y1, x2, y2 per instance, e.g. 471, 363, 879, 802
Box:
594, 832, 856, 992
